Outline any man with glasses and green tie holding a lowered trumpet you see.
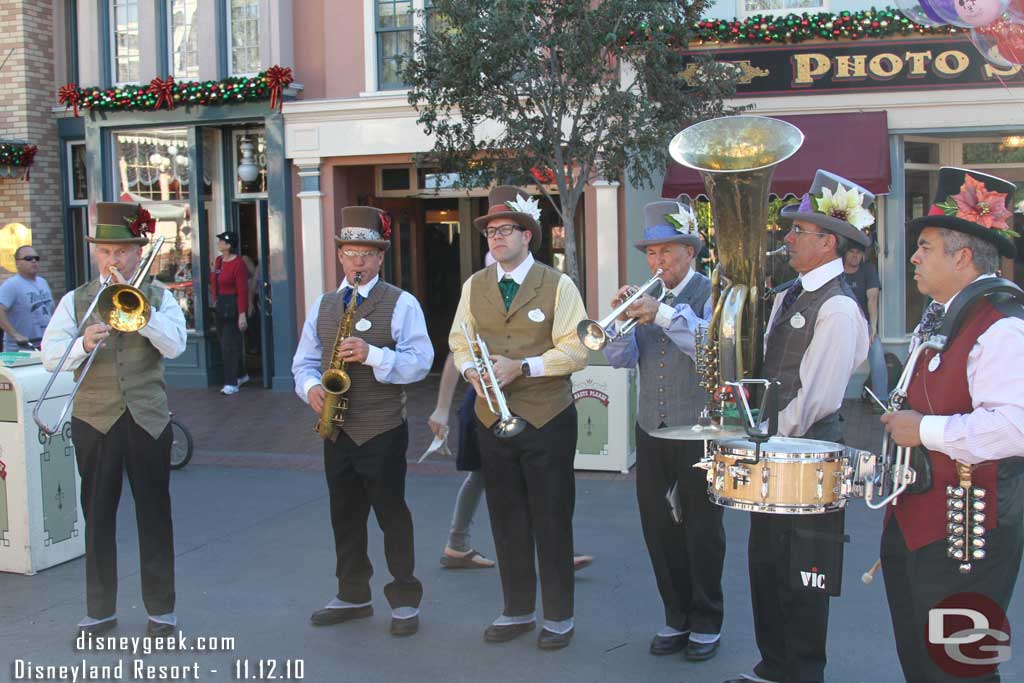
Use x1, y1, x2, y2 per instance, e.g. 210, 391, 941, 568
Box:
449, 185, 587, 649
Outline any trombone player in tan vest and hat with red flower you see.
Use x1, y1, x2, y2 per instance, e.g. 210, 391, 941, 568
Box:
42, 202, 185, 636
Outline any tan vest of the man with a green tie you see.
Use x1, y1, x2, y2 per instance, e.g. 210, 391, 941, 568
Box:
469, 263, 572, 428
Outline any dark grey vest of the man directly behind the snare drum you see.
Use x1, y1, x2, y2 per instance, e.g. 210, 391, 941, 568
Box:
764, 275, 856, 441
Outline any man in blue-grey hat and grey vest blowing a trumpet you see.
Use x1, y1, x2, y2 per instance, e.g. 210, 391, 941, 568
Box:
604, 197, 725, 660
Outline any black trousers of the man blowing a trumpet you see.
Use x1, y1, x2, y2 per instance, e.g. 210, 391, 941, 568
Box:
636, 425, 725, 634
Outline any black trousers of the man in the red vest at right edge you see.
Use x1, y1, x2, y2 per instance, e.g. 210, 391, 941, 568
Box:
882, 518, 1024, 683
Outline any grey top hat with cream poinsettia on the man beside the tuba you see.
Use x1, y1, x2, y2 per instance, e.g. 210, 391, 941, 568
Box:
779, 169, 874, 247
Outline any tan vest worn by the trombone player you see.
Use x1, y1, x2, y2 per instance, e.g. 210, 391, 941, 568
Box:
72, 280, 169, 438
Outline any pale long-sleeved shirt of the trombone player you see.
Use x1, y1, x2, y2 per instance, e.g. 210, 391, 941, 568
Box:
41, 278, 187, 372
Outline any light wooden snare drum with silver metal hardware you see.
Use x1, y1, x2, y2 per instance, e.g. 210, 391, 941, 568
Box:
708, 436, 849, 515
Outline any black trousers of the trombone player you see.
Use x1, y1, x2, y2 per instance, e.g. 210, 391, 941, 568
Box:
71, 411, 174, 618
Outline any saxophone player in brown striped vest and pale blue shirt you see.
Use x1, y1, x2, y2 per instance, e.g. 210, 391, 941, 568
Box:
292, 207, 434, 636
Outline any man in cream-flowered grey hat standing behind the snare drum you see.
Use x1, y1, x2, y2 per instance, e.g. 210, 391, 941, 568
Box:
727, 170, 874, 683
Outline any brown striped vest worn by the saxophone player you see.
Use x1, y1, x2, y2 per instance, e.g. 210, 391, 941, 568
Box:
316, 280, 406, 445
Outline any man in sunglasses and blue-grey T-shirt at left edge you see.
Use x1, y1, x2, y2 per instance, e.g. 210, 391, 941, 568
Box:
0, 245, 53, 351
